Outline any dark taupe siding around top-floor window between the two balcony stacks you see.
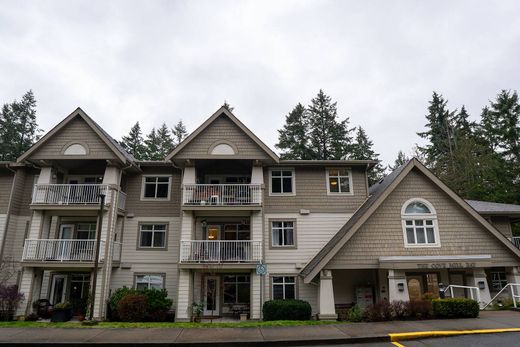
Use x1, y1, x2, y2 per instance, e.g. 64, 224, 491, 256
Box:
125, 167, 181, 217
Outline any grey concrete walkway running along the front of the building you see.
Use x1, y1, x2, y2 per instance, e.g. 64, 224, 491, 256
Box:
0, 311, 520, 346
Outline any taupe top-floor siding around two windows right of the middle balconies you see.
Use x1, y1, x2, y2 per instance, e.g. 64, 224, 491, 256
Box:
264, 167, 367, 213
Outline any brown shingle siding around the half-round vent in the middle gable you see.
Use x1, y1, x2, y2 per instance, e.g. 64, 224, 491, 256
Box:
175, 115, 269, 159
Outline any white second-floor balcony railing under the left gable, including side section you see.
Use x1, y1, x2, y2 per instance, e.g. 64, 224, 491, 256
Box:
22, 239, 121, 263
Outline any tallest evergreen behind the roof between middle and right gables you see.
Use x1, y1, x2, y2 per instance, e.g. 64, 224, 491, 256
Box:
308, 89, 353, 159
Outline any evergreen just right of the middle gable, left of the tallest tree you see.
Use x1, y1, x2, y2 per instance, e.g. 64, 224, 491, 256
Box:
275, 103, 313, 159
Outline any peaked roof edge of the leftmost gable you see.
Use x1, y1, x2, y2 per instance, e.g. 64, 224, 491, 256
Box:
17, 107, 136, 163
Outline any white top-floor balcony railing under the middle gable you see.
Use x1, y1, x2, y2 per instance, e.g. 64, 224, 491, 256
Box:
182, 184, 262, 206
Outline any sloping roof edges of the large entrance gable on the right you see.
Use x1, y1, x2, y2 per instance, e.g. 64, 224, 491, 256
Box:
300, 158, 520, 283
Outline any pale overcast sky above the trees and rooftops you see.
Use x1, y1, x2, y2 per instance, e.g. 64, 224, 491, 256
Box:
0, 0, 520, 164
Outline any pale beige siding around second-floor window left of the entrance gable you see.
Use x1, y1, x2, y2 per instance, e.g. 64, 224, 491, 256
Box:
264, 213, 351, 270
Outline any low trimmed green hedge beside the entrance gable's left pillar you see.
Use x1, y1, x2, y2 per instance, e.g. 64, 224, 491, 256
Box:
262, 299, 312, 321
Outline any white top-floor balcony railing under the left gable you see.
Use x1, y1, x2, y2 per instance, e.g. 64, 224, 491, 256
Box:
32, 184, 110, 205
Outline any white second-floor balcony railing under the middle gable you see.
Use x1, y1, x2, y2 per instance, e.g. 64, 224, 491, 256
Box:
180, 240, 262, 263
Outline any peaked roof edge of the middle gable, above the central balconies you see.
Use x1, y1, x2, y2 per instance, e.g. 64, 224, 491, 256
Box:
165, 106, 280, 163
